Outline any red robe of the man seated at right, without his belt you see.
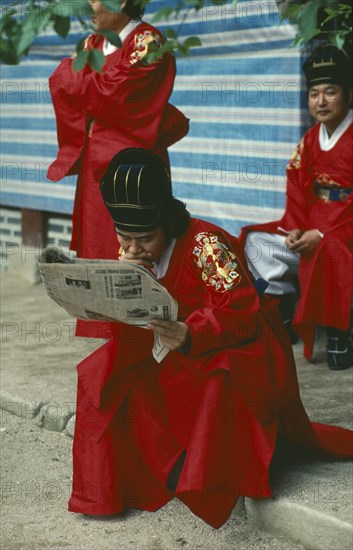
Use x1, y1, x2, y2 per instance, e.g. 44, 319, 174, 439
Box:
241, 123, 353, 360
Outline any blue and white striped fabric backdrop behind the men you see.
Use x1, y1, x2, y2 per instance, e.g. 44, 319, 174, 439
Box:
1, 0, 310, 234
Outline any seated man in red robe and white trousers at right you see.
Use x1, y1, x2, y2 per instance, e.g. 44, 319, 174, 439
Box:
242, 44, 353, 370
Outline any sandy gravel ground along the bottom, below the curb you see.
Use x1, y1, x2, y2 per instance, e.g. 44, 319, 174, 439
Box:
0, 411, 303, 550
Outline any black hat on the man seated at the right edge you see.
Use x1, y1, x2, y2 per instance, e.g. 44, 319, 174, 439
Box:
303, 43, 352, 89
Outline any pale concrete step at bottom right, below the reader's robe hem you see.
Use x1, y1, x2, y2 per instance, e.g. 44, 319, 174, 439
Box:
245, 459, 353, 550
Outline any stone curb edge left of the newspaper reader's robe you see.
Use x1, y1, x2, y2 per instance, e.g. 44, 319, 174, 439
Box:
0, 391, 76, 438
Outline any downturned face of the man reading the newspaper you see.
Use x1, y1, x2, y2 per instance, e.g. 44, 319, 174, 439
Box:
116, 227, 169, 262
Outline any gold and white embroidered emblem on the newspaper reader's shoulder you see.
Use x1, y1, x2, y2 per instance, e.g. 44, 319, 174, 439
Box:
193, 233, 241, 292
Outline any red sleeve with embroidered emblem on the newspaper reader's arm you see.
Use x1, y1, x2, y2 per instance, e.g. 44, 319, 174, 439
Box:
185, 232, 259, 357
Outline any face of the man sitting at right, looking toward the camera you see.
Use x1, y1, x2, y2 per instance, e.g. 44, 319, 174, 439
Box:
308, 84, 351, 133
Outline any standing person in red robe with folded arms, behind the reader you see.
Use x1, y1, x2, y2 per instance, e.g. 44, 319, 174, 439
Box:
48, 0, 188, 264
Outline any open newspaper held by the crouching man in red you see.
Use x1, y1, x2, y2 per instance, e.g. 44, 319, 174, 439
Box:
38, 246, 178, 363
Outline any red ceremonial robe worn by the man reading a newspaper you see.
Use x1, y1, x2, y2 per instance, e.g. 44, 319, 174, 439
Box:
69, 219, 352, 528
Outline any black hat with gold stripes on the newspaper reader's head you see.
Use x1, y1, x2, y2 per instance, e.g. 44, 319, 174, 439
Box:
100, 147, 173, 232
